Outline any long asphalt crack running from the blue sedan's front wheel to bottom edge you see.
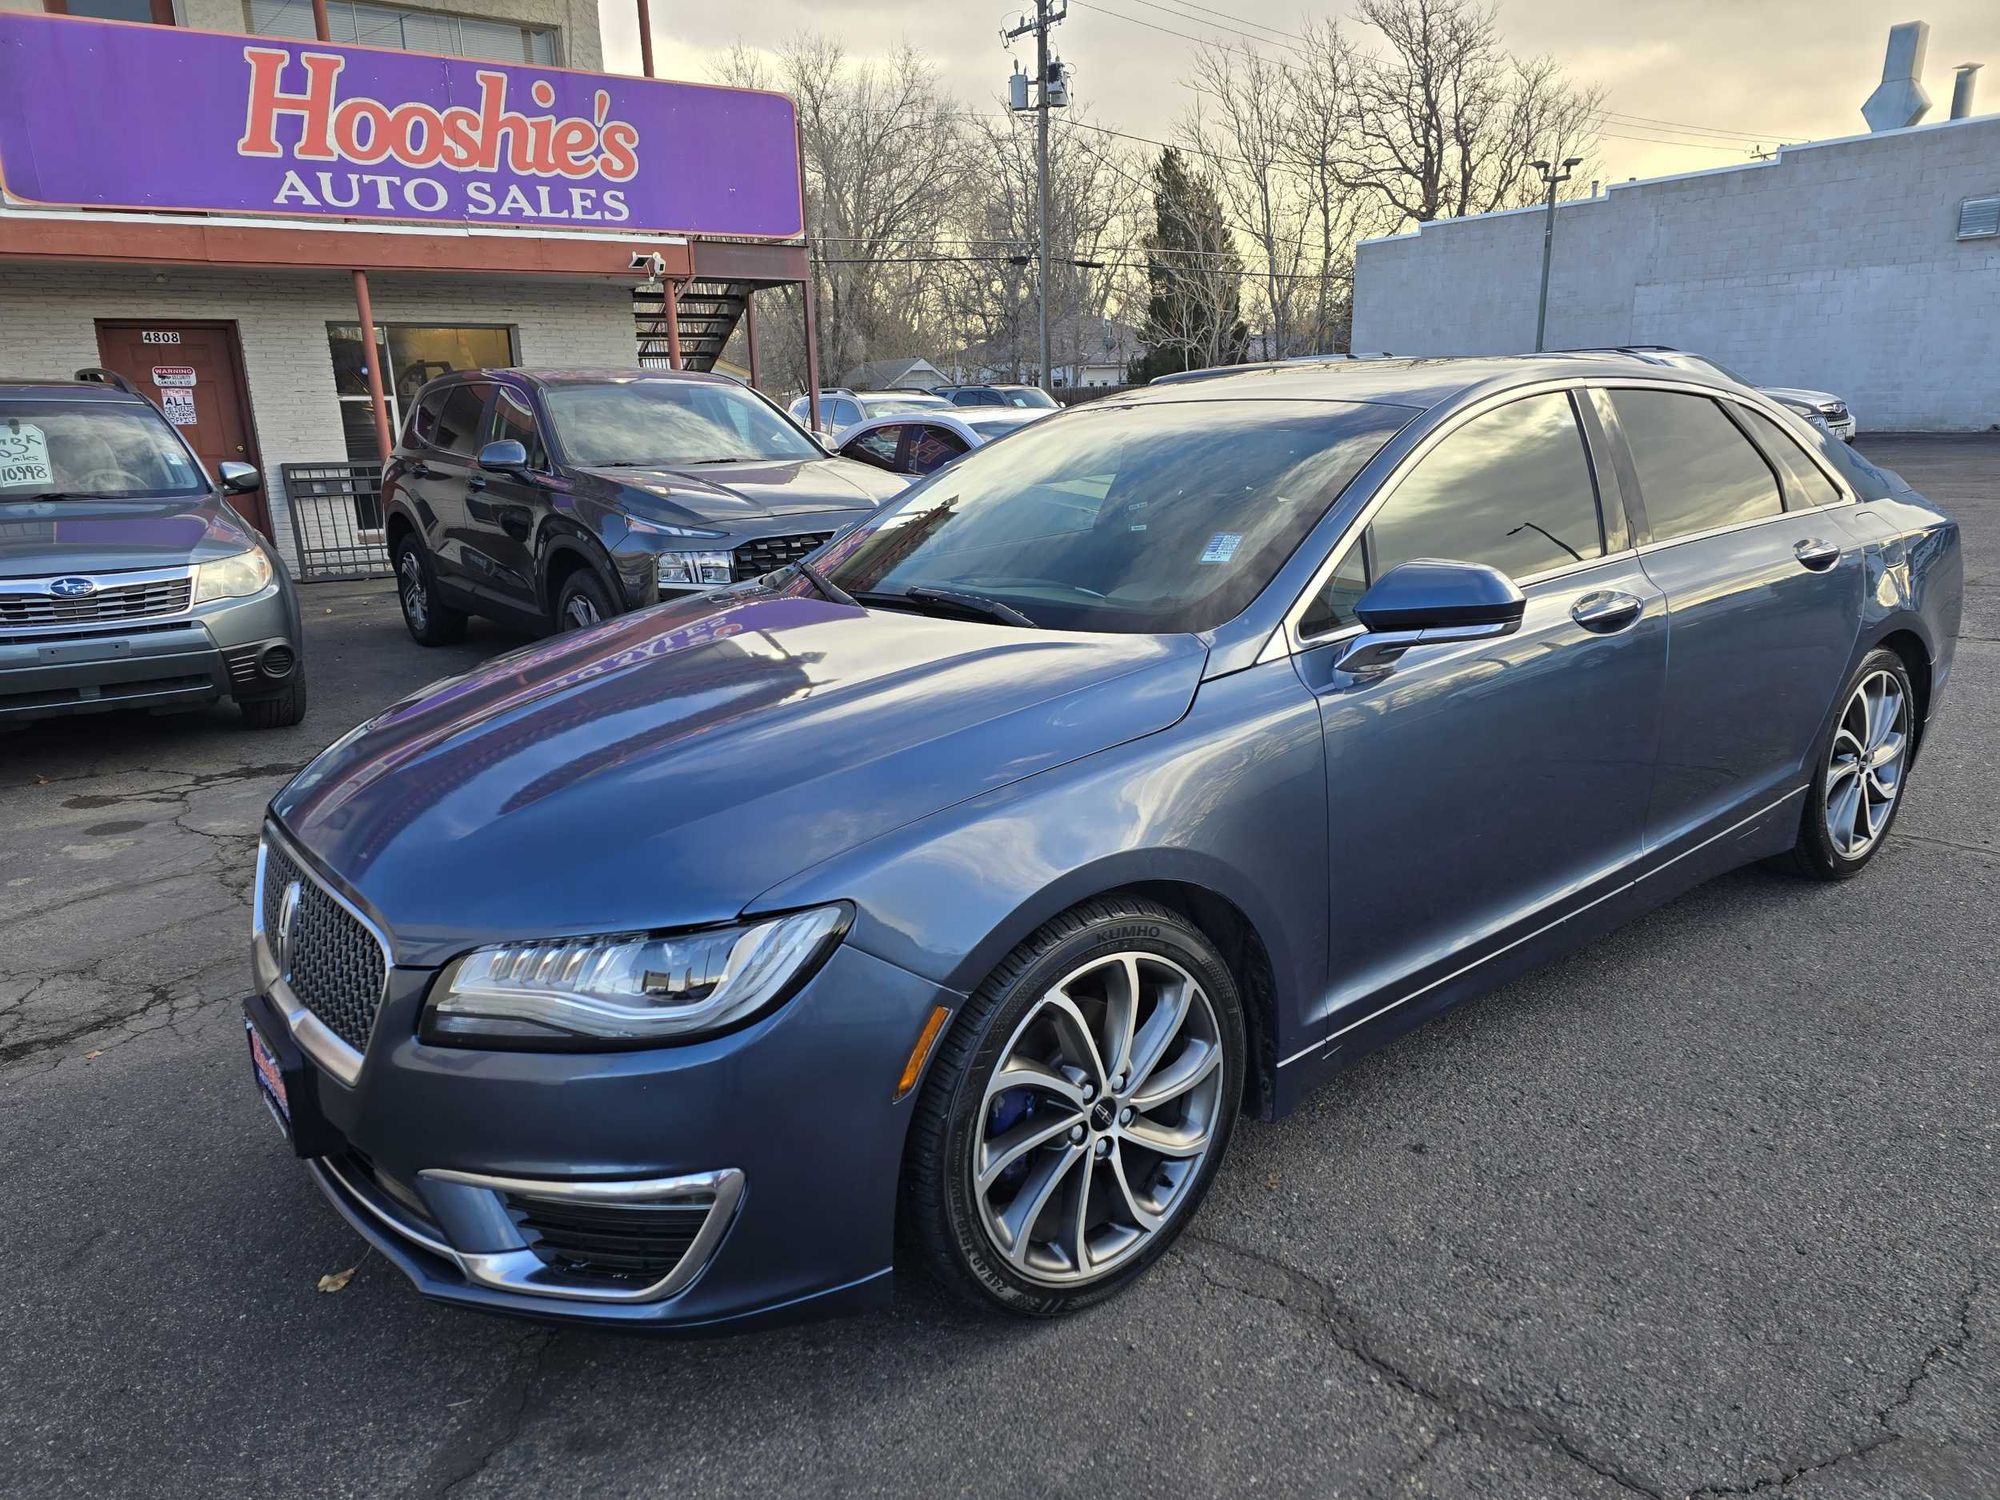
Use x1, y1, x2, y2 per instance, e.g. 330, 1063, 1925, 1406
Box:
1182, 1234, 1668, 1500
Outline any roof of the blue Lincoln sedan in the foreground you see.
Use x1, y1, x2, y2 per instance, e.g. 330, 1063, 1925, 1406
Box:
1108, 352, 1734, 410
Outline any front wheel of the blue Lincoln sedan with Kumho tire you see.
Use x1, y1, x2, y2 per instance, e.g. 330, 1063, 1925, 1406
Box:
904, 896, 1246, 1318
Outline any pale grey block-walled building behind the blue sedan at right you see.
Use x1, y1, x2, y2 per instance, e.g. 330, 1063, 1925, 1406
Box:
1354, 116, 2000, 432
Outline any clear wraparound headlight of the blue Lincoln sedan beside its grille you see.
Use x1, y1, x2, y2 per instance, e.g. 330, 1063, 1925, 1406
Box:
422, 906, 850, 1048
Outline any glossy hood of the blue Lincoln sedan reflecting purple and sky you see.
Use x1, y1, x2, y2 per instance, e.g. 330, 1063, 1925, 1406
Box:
272, 590, 1208, 964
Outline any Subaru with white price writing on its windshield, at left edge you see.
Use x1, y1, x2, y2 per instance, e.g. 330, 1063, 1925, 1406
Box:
0, 370, 306, 728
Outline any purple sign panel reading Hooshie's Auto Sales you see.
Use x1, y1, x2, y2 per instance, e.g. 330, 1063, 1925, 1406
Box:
0, 12, 804, 238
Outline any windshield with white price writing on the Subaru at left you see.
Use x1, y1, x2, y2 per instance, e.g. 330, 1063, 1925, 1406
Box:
0, 398, 208, 500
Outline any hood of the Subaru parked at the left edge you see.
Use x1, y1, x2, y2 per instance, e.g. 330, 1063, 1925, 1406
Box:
0, 496, 256, 578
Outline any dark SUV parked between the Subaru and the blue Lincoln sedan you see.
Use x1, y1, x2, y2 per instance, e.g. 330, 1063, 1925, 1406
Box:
382, 370, 900, 646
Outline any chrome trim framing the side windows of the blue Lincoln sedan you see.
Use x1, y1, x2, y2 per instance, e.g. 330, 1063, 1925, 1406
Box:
1256, 376, 1856, 666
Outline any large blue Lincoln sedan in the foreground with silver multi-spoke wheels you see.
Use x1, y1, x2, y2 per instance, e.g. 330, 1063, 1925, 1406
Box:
248, 358, 1962, 1332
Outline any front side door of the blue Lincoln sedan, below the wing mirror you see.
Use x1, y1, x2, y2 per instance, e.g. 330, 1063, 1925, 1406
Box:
1294, 390, 1666, 1026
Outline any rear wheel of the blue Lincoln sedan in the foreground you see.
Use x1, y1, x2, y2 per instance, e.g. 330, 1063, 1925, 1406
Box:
1782, 650, 1916, 880
